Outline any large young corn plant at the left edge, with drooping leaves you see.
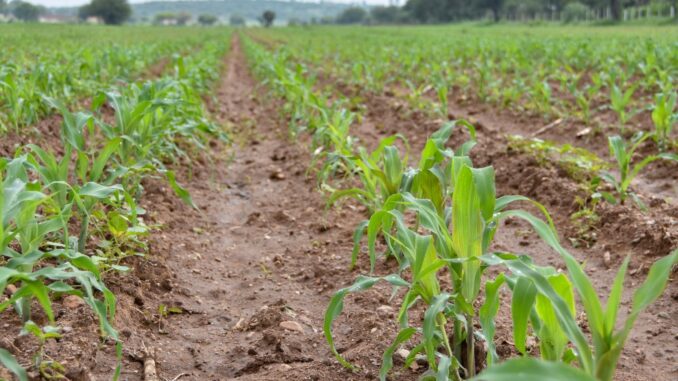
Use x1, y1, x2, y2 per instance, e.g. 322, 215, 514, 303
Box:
0, 156, 117, 338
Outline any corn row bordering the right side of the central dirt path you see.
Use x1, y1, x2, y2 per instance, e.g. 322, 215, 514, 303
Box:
244, 36, 678, 381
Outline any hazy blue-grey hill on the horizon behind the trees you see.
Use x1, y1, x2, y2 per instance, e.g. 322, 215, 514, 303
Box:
51, 0, 358, 24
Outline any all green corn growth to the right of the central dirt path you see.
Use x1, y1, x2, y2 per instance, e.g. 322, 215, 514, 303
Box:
246, 26, 678, 381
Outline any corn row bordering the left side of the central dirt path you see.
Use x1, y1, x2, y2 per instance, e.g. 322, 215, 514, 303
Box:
0, 39, 228, 381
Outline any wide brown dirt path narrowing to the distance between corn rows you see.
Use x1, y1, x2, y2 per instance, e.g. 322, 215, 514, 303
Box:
96, 37, 424, 381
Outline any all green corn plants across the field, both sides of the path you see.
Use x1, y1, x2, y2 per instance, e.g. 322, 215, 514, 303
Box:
0, 20, 678, 381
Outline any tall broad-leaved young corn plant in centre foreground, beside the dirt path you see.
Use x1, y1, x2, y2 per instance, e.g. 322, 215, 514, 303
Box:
324, 157, 553, 380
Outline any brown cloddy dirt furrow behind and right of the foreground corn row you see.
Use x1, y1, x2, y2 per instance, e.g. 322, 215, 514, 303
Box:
320, 73, 678, 381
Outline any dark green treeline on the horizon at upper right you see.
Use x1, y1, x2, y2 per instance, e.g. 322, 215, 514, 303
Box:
332, 0, 678, 24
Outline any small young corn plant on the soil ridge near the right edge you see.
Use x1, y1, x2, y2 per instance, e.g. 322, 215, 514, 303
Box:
594, 132, 678, 210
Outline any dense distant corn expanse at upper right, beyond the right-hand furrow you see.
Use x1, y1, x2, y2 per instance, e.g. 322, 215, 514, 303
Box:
251, 27, 678, 150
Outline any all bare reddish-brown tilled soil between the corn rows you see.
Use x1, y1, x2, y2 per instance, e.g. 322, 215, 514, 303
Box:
0, 37, 678, 381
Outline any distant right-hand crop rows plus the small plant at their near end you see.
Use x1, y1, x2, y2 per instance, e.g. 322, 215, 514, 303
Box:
252, 29, 678, 223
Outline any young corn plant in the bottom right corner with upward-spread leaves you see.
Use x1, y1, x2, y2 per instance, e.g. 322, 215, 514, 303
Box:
474, 243, 678, 381
